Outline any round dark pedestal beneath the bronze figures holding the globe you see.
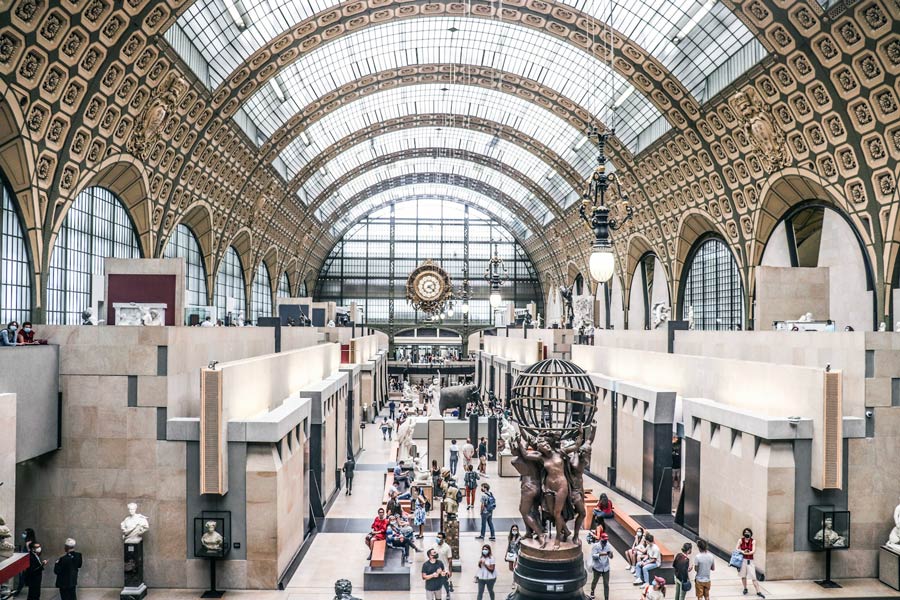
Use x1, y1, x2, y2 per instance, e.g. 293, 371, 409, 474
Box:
508, 539, 587, 600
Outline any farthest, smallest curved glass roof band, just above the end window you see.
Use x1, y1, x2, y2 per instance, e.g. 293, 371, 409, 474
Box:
331, 183, 532, 240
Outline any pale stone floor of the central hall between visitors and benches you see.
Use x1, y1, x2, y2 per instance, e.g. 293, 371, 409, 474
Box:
63, 414, 900, 600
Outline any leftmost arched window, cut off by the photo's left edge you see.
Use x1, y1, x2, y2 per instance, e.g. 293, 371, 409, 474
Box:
0, 177, 31, 327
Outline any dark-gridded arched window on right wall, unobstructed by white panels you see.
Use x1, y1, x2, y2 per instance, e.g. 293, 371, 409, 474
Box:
682, 238, 744, 331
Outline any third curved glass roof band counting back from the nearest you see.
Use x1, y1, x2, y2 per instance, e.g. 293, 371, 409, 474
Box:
279, 84, 593, 184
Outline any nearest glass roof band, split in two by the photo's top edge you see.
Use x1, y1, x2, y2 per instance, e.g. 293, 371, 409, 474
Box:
167, 0, 755, 103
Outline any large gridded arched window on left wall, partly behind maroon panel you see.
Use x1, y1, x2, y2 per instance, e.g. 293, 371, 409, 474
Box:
47, 187, 141, 325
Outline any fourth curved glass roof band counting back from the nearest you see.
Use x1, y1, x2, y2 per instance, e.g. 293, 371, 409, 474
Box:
301, 127, 580, 208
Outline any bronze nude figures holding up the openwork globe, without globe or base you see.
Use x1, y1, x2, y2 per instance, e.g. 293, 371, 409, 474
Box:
511, 423, 596, 549
